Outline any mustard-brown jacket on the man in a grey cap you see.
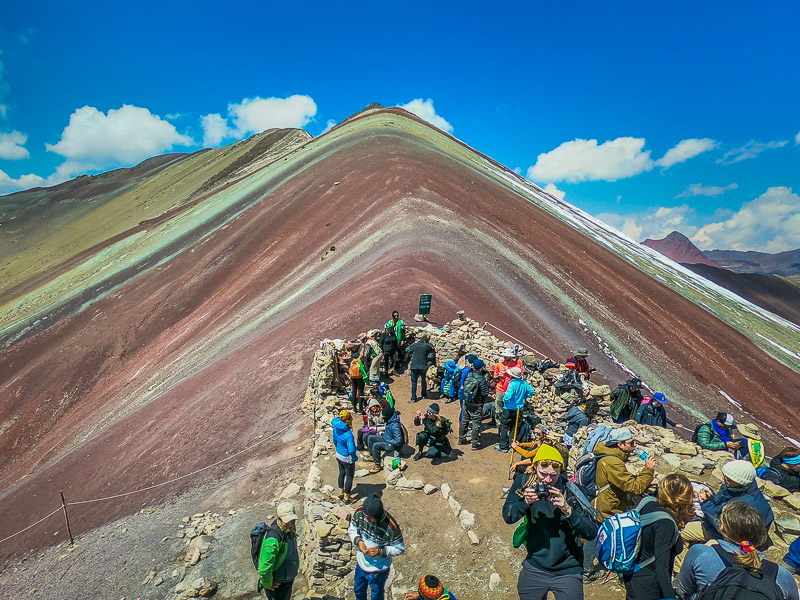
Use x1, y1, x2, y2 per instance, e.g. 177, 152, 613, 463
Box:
594, 443, 655, 519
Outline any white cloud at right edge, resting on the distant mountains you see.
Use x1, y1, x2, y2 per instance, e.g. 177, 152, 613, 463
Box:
691, 186, 800, 252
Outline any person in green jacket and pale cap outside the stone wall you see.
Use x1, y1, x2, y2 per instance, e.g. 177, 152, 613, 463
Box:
258, 502, 300, 600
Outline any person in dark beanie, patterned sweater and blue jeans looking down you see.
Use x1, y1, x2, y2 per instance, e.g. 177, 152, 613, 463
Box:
347, 492, 406, 600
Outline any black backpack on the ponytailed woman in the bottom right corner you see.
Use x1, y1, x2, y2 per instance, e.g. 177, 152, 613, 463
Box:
695, 544, 783, 600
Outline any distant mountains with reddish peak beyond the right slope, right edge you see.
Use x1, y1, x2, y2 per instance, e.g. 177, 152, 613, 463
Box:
642, 231, 800, 325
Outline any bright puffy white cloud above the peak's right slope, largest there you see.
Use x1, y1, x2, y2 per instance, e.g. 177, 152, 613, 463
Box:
527, 137, 654, 183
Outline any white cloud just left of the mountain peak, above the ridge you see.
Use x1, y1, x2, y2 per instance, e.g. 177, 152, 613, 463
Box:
201, 94, 317, 147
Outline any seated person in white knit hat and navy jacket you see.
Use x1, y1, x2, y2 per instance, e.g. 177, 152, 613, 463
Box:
681, 460, 775, 550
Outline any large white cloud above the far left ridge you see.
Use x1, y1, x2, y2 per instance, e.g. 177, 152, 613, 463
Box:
45, 104, 194, 180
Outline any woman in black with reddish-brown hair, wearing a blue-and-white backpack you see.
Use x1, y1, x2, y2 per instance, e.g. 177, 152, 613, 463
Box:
622, 473, 694, 600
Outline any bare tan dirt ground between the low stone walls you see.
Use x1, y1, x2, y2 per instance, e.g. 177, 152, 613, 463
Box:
323, 368, 625, 600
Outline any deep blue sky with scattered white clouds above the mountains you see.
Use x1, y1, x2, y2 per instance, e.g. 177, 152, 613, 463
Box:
0, 0, 800, 252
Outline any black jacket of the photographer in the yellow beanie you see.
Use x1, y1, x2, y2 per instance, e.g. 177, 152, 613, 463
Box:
503, 474, 597, 575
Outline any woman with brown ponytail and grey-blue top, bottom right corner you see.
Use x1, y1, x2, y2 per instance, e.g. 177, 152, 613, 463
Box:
678, 502, 800, 600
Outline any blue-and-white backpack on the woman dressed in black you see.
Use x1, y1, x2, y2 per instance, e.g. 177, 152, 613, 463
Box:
595, 496, 680, 574
